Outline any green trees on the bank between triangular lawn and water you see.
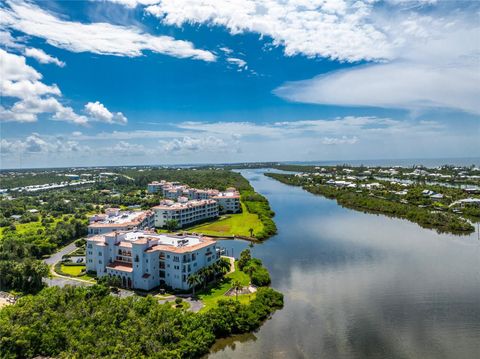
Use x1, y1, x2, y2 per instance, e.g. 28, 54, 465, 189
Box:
240, 191, 277, 240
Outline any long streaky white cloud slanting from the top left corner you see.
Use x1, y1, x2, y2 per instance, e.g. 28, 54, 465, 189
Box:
0, 1, 215, 61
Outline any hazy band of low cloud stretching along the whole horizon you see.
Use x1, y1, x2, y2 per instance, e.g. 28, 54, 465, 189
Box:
1, 116, 480, 167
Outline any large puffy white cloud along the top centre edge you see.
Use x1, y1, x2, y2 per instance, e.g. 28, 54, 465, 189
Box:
146, 0, 392, 61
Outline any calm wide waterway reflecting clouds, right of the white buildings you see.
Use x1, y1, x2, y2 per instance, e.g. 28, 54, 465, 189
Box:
209, 171, 480, 359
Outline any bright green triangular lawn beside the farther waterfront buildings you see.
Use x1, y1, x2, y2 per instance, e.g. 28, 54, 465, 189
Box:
188, 203, 263, 237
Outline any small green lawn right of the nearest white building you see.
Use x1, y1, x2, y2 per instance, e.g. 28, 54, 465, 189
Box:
197, 263, 255, 311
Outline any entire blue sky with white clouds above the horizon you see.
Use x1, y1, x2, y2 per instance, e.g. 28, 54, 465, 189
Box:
0, 0, 480, 168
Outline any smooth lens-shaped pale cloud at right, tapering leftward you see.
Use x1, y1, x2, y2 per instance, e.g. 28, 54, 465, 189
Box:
275, 62, 480, 114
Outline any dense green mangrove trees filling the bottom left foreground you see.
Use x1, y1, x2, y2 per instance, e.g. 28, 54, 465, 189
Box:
0, 285, 283, 358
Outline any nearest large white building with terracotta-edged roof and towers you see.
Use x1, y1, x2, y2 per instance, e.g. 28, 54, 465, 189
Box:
86, 231, 220, 290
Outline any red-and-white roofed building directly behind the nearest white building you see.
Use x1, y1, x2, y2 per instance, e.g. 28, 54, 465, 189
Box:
88, 208, 155, 237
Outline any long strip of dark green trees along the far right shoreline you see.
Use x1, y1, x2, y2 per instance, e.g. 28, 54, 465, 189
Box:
265, 173, 475, 234
